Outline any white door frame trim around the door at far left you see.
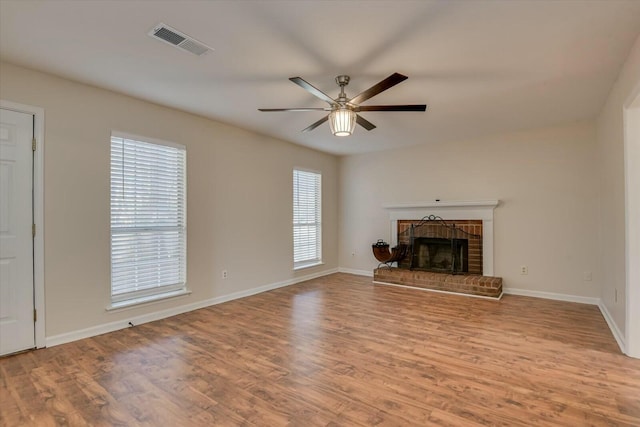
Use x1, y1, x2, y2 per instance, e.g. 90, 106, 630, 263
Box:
0, 99, 46, 348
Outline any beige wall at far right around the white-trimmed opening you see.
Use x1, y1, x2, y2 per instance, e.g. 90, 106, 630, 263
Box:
597, 34, 640, 342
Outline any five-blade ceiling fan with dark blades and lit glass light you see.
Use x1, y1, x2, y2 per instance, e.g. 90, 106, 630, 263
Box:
258, 73, 427, 136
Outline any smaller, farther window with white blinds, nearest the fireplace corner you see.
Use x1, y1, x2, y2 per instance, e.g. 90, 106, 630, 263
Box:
293, 169, 322, 269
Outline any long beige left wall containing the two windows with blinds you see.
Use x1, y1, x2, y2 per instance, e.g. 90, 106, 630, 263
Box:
0, 64, 338, 337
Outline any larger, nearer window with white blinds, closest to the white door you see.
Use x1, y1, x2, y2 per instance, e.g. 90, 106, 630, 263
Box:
111, 134, 187, 306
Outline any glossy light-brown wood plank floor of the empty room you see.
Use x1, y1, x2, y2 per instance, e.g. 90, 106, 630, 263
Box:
0, 274, 640, 427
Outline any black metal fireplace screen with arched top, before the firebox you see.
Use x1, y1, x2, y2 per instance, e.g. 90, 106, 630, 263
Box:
399, 215, 482, 274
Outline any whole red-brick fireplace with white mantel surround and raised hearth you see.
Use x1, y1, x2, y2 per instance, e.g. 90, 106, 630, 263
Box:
374, 200, 502, 299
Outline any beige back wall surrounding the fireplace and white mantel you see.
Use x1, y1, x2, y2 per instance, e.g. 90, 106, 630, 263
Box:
340, 122, 602, 298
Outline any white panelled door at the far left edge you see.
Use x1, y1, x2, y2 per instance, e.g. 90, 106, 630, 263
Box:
0, 109, 35, 355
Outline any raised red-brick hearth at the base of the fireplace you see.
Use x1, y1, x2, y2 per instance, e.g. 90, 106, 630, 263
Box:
373, 267, 502, 298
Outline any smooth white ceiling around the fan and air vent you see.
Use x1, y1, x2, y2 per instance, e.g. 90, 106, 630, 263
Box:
0, 0, 640, 155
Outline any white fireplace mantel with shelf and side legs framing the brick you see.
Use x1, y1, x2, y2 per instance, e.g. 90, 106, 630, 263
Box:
383, 200, 500, 276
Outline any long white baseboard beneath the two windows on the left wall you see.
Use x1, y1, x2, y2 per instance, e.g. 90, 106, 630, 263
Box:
46, 268, 338, 347
